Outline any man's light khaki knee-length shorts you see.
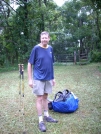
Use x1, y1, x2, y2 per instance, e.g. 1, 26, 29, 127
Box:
33, 80, 53, 95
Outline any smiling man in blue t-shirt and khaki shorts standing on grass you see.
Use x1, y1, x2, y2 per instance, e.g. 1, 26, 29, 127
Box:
28, 31, 58, 132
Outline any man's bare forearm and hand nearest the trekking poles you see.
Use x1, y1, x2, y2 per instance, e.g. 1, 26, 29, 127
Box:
28, 62, 33, 88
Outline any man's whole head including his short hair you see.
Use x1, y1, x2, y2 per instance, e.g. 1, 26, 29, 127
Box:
40, 31, 50, 46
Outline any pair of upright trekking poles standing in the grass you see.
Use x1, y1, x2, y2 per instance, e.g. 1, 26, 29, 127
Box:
19, 64, 26, 134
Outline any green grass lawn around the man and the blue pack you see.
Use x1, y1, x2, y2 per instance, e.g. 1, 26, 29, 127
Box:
0, 63, 101, 134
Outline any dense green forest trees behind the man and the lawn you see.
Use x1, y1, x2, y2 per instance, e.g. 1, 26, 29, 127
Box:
0, 0, 101, 67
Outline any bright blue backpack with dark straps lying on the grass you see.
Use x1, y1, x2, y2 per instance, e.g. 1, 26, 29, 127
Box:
48, 89, 79, 113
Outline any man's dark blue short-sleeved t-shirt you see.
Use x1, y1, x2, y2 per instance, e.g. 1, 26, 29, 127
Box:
28, 45, 54, 80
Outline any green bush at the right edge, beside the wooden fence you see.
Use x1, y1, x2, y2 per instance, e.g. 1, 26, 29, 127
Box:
91, 50, 101, 62
